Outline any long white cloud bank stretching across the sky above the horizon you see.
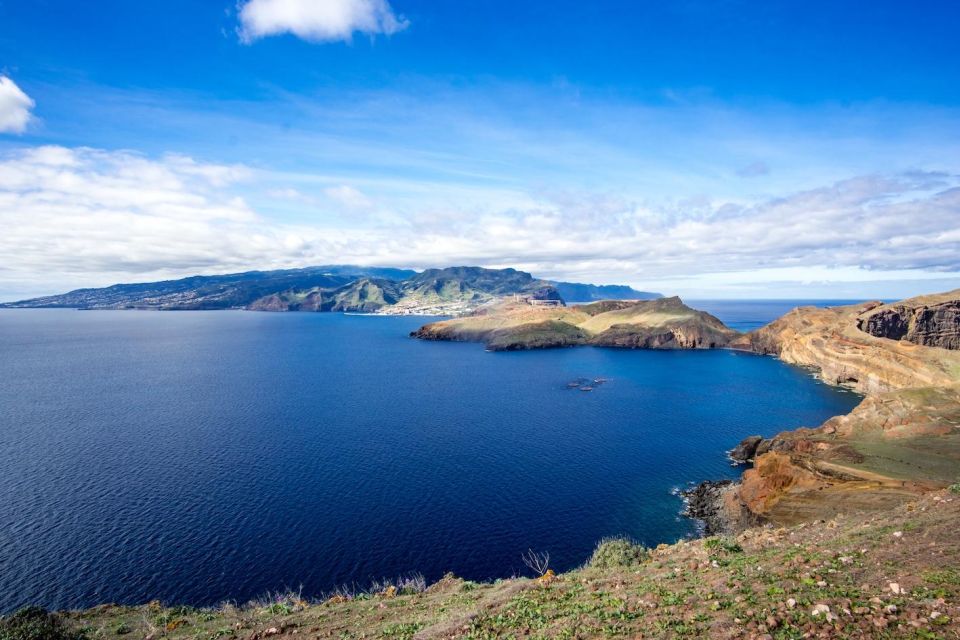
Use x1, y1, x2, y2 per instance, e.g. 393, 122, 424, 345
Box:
0, 147, 960, 299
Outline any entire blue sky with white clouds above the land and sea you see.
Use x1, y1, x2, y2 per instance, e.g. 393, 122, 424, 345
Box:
0, 0, 960, 300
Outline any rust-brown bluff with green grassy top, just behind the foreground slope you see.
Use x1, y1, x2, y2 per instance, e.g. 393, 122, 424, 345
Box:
738, 386, 960, 524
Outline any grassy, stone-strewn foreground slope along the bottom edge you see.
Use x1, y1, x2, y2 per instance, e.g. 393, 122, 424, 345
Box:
43, 491, 960, 640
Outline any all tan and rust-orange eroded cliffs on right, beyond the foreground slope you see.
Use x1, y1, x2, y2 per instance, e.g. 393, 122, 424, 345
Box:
732, 291, 960, 523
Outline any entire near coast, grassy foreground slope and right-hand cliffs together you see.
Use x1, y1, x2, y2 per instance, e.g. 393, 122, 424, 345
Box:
0, 290, 960, 640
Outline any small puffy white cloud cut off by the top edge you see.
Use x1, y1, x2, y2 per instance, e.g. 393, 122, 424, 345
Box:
240, 0, 410, 42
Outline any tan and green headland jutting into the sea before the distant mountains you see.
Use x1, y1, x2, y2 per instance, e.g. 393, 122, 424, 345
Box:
411, 297, 737, 351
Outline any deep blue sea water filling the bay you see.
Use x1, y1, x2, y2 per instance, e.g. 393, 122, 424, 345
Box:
0, 308, 858, 612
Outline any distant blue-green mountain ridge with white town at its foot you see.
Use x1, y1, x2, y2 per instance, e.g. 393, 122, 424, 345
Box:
0, 265, 660, 314
